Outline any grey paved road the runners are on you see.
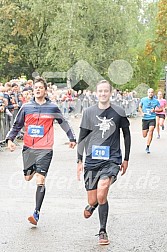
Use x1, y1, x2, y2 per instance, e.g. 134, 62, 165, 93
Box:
0, 118, 167, 252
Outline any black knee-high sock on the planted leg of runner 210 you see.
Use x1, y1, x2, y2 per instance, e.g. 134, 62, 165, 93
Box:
98, 201, 109, 232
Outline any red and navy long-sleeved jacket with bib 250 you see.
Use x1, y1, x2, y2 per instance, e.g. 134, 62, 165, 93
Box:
6, 98, 76, 149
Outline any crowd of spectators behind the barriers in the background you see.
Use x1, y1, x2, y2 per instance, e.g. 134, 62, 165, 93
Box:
0, 80, 139, 145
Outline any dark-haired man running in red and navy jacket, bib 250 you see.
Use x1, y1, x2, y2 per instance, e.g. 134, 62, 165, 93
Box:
6, 77, 76, 225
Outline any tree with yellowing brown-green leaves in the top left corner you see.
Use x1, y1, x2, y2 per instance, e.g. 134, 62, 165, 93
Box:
0, 0, 61, 77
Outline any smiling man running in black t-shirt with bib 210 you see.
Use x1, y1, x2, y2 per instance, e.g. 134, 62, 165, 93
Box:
77, 80, 131, 245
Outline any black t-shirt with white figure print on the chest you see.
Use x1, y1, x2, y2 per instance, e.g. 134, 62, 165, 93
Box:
80, 104, 129, 169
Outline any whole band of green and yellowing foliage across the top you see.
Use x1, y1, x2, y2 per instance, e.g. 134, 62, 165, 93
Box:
0, 0, 166, 90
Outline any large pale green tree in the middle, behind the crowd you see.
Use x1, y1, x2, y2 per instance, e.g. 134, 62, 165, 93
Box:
48, 0, 143, 85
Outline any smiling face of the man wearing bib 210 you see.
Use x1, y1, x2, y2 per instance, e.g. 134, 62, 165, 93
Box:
96, 83, 111, 104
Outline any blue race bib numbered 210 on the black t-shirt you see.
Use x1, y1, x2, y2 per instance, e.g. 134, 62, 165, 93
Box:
92, 145, 110, 159
